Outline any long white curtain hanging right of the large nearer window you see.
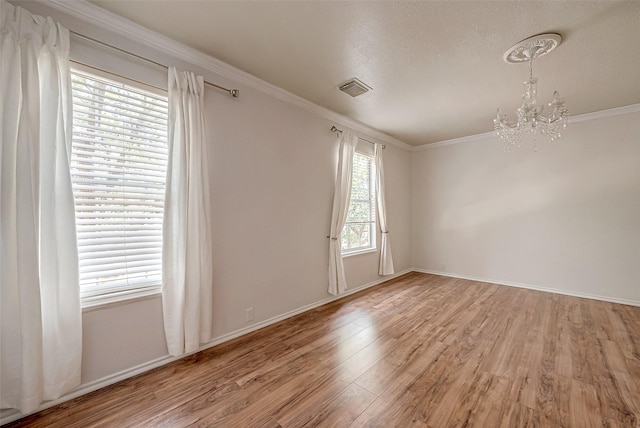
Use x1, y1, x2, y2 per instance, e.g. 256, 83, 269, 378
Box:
162, 67, 213, 356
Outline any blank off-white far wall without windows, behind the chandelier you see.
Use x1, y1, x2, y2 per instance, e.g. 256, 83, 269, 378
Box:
412, 108, 640, 304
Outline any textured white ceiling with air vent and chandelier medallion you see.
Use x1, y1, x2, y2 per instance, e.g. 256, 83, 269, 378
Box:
87, 0, 640, 145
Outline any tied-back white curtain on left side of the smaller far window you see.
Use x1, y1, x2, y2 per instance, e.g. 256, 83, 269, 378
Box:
329, 131, 358, 296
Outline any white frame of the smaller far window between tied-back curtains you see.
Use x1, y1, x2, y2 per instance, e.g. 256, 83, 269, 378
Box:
340, 149, 378, 257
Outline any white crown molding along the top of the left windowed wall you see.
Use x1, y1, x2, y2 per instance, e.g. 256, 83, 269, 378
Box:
39, 0, 413, 151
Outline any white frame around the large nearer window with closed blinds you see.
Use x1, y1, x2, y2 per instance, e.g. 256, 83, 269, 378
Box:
69, 63, 169, 309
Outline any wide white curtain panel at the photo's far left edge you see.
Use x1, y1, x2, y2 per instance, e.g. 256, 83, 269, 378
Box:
0, 0, 82, 413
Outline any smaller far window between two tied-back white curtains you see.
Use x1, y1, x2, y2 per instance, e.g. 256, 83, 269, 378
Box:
341, 153, 376, 254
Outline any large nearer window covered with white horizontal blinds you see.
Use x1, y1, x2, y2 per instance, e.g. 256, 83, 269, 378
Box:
71, 71, 168, 306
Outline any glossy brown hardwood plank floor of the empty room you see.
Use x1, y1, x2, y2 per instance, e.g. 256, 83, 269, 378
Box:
10, 273, 640, 428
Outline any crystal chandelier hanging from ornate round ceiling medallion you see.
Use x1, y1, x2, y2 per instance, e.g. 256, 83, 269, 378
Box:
493, 34, 569, 151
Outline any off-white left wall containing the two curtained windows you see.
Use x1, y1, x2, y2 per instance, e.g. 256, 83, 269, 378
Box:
8, 2, 411, 398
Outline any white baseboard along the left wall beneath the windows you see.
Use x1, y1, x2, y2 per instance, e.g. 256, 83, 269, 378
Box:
0, 269, 415, 425
